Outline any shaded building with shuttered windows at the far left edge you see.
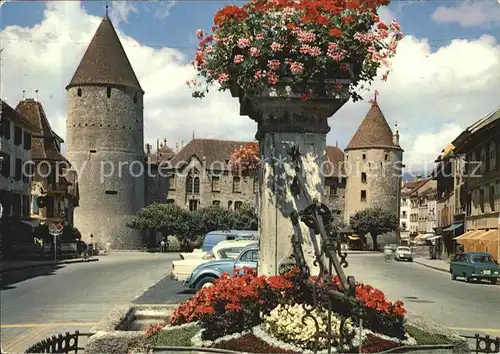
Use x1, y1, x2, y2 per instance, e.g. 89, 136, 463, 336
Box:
0, 100, 39, 244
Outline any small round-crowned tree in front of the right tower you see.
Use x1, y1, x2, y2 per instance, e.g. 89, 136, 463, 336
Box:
349, 207, 399, 250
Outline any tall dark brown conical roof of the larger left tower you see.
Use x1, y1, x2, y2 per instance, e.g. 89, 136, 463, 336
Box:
66, 15, 144, 92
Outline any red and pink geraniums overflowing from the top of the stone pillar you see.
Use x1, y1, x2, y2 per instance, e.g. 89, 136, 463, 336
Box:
188, 0, 402, 101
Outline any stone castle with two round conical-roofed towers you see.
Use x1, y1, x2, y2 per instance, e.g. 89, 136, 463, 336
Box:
66, 16, 403, 249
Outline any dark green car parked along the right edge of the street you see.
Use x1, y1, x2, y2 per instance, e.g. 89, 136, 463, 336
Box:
450, 252, 500, 284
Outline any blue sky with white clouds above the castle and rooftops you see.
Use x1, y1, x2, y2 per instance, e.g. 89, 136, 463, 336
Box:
0, 0, 500, 174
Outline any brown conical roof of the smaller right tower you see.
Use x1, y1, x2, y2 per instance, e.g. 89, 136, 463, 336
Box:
346, 102, 401, 150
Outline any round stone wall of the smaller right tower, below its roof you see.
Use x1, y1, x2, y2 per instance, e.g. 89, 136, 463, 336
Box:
344, 148, 403, 223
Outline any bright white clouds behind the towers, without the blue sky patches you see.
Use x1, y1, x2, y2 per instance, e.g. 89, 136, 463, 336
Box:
1, 1, 500, 174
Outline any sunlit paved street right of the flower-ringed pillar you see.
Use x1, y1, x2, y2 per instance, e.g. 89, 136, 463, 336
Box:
345, 254, 500, 336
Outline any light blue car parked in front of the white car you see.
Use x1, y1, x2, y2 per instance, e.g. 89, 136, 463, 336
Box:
184, 242, 259, 291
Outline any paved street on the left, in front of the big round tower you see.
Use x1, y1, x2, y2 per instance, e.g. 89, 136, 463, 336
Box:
0, 252, 180, 353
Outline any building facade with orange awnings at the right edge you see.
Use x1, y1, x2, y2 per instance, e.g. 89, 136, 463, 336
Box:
453, 109, 500, 260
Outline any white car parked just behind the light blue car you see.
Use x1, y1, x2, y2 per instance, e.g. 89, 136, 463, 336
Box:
171, 240, 255, 281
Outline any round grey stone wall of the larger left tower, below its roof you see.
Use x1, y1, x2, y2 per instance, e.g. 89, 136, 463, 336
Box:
67, 86, 145, 249
